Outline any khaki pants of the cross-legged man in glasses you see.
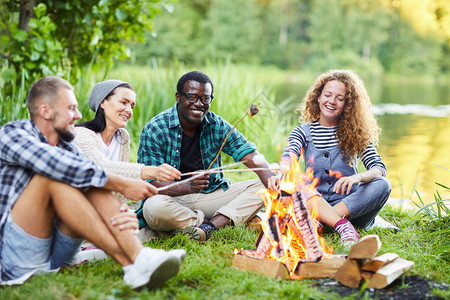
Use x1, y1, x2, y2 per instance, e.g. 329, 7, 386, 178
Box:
144, 179, 264, 231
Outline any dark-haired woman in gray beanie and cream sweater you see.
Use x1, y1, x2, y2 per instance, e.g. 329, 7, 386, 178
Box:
73, 79, 180, 205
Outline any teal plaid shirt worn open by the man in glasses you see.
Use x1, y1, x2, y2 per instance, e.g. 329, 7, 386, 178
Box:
138, 104, 256, 193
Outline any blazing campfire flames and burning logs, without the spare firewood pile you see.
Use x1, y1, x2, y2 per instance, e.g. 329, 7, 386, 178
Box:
235, 157, 343, 278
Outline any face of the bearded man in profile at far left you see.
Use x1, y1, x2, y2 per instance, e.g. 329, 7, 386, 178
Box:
51, 88, 81, 142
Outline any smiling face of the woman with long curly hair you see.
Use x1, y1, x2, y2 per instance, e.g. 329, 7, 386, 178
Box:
317, 80, 347, 127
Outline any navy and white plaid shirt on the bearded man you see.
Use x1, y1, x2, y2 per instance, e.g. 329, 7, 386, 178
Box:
0, 120, 108, 274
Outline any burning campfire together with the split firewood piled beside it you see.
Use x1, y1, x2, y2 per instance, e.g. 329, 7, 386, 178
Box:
233, 160, 414, 288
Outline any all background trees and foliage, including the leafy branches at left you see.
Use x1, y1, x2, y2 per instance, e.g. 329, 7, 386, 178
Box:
0, 0, 450, 120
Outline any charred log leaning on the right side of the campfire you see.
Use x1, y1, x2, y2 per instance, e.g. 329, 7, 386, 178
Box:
292, 191, 323, 261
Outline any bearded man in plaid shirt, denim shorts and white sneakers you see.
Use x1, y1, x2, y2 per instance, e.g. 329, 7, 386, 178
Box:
0, 77, 185, 288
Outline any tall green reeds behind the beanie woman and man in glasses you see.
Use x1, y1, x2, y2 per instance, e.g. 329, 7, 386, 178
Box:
0, 61, 298, 169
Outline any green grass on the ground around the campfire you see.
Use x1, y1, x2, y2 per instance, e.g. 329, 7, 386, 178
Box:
0, 207, 450, 299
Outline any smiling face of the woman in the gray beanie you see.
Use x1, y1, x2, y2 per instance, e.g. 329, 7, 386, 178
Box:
100, 87, 136, 129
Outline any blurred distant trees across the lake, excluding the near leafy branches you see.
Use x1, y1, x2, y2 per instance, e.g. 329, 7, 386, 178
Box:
134, 0, 450, 76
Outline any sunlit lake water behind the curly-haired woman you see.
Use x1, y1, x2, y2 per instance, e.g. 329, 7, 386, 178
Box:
276, 78, 450, 206
